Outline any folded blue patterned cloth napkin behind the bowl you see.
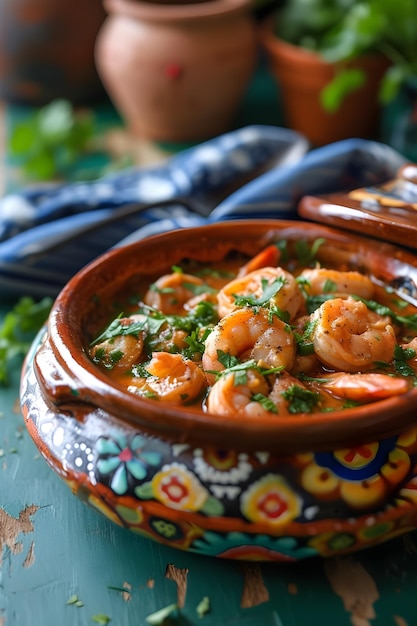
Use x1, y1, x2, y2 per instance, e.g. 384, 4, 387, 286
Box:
0, 125, 406, 301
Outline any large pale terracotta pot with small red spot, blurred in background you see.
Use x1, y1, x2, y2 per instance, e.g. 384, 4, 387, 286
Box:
96, 0, 257, 141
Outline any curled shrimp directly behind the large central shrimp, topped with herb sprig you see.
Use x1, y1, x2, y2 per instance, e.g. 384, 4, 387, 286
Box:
217, 267, 303, 321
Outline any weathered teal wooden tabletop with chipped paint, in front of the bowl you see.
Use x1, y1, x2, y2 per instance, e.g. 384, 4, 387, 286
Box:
0, 307, 417, 626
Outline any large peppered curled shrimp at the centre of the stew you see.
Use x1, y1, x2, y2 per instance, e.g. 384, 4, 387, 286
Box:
202, 308, 296, 382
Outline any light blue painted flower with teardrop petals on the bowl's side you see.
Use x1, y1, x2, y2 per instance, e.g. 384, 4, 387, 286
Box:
96, 435, 161, 495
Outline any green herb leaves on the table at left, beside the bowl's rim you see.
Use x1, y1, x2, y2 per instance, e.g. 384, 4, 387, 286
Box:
0, 296, 52, 385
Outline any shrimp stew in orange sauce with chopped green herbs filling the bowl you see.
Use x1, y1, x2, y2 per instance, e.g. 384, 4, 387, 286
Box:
89, 245, 417, 419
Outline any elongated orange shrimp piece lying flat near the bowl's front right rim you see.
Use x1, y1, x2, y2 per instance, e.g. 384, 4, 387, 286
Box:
321, 372, 409, 402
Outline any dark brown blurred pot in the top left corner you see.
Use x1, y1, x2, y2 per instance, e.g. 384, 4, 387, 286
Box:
0, 0, 106, 105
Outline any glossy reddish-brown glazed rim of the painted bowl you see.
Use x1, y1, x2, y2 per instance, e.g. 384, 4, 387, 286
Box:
43, 219, 417, 455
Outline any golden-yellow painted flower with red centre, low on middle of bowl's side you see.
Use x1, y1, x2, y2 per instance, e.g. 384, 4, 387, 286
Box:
241, 474, 301, 526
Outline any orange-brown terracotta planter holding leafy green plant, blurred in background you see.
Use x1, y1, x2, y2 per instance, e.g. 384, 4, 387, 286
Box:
259, 23, 388, 146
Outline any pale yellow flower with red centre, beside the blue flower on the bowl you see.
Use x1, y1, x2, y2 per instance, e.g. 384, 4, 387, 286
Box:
152, 463, 209, 511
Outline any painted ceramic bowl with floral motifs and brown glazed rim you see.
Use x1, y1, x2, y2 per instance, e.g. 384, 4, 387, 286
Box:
21, 220, 417, 561
